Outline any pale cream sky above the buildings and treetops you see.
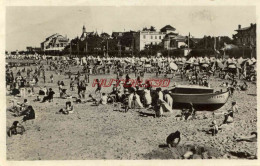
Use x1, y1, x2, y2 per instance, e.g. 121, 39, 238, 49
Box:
6, 6, 256, 51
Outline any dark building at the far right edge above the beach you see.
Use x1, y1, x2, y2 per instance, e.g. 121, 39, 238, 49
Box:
233, 23, 256, 47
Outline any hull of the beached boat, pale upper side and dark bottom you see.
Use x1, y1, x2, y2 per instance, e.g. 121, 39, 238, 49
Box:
171, 91, 229, 111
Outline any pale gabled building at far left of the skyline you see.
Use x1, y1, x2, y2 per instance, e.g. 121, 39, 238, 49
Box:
41, 33, 69, 51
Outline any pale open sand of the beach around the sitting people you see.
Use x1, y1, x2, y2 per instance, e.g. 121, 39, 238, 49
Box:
6, 63, 257, 160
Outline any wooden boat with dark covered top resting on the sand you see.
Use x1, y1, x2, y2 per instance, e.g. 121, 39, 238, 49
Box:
171, 86, 229, 111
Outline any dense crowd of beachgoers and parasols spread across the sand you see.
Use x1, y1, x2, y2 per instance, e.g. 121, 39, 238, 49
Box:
6, 53, 256, 158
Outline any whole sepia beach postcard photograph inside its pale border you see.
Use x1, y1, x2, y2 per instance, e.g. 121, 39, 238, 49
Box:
2, 4, 258, 162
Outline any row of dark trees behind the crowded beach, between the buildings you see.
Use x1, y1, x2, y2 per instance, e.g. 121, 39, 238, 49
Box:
8, 26, 255, 57
